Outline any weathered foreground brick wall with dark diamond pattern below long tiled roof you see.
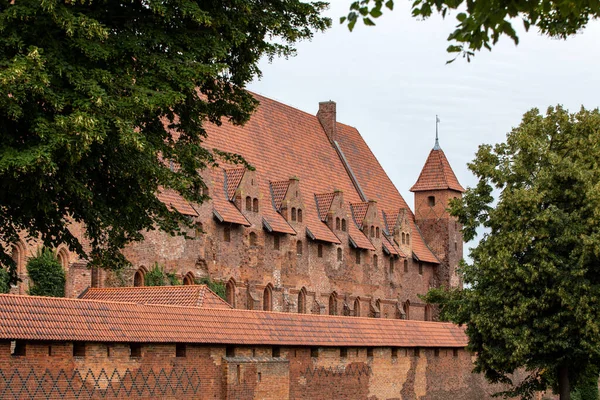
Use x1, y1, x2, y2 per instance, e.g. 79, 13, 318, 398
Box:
0, 341, 551, 400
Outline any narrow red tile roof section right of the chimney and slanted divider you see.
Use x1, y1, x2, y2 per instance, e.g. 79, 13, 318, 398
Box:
337, 122, 439, 264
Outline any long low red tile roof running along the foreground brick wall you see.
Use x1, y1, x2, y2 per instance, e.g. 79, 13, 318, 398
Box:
0, 294, 467, 348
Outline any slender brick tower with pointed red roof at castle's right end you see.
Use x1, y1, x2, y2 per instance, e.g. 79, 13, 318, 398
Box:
410, 136, 465, 287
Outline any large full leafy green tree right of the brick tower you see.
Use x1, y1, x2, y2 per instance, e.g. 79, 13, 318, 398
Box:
426, 106, 600, 400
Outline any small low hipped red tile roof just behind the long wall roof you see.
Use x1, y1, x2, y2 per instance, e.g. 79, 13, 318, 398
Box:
80, 285, 232, 308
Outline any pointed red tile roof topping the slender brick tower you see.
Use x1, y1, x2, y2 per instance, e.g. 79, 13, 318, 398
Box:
410, 149, 465, 193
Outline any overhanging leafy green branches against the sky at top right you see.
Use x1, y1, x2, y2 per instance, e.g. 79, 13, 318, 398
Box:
341, 0, 600, 62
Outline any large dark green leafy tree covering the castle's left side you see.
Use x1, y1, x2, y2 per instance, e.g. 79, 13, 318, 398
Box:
0, 0, 330, 282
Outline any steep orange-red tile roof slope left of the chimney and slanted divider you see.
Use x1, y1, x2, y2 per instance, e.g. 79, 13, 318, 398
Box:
203, 95, 372, 247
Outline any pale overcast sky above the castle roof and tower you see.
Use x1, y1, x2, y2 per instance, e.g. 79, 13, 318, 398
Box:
249, 0, 600, 216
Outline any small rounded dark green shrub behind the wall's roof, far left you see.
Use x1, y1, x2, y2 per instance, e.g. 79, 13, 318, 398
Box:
27, 248, 66, 297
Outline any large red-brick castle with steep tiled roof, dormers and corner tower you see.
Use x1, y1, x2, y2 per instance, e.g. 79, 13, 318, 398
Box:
12, 95, 464, 320
